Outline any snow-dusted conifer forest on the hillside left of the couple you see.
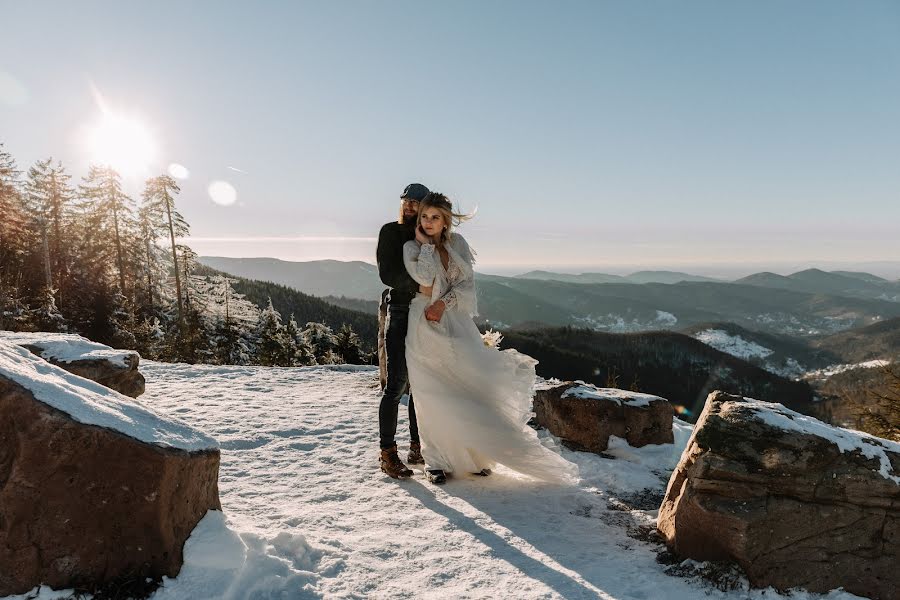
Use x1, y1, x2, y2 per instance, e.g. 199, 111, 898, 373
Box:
0, 143, 372, 366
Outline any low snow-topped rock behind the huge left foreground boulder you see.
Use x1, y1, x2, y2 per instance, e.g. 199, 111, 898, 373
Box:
0, 331, 144, 398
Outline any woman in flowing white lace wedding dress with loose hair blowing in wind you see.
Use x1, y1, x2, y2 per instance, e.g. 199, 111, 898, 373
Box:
403, 193, 576, 483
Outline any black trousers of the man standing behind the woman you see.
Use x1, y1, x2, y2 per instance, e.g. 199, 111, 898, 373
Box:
378, 304, 419, 449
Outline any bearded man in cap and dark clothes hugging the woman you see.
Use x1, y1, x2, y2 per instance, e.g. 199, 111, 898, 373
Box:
377, 183, 429, 479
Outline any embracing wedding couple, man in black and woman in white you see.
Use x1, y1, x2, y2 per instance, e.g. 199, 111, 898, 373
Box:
377, 183, 576, 484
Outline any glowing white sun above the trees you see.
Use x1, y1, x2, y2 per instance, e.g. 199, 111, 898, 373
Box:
87, 112, 156, 176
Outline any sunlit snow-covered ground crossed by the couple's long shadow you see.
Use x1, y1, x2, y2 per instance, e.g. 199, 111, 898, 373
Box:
5, 361, 856, 600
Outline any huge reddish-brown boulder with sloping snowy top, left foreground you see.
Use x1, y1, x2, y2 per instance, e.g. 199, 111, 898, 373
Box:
0, 341, 220, 596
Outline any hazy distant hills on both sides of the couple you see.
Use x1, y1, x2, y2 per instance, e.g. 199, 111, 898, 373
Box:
200, 257, 900, 336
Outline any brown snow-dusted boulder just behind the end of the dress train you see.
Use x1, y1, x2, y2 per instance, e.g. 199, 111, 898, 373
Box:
534, 382, 674, 452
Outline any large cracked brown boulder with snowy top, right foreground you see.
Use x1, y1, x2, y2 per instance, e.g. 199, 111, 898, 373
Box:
658, 392, 900, 600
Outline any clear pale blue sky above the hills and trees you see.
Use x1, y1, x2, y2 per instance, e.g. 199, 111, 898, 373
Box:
0, 0, 900, 270
